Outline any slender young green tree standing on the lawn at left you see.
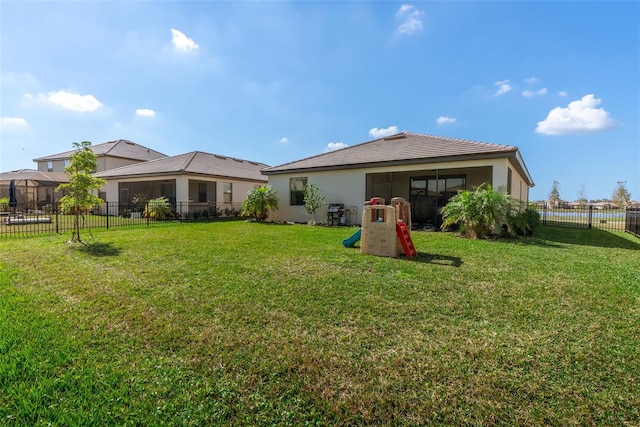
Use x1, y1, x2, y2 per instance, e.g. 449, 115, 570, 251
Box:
56, 141, 106, 243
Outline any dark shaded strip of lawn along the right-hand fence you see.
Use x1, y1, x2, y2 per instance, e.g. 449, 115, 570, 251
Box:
521, 227, 640, 251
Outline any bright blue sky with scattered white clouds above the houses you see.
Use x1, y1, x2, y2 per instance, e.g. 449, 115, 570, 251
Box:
0, 0, 640, 200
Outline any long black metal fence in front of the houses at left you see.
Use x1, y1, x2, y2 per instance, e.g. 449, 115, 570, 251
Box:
0, 202, 242, 239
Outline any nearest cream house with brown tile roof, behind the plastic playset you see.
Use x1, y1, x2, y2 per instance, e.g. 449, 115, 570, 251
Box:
262, 132, 534, 227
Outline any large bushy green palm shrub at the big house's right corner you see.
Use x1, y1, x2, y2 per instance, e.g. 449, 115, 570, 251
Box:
441, 183, 519, 239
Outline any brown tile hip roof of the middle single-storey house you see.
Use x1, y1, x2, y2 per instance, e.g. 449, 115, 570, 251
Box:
96, 151, 268, 182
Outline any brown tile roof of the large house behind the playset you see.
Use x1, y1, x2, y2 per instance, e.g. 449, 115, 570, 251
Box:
263, 132, 518, 175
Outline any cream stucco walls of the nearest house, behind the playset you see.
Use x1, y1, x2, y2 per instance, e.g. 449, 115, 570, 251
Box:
269, 158, 528, 224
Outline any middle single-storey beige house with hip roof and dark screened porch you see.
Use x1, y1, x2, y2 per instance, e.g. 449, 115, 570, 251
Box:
95, 151, 267, 214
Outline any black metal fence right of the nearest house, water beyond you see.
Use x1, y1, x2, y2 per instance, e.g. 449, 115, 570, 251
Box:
538, 205, 640, 236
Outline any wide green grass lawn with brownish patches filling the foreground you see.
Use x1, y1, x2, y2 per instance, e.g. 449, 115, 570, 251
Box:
0, 222, 640, 426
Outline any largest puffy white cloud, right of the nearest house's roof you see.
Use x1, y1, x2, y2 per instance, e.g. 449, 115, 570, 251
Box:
536, 94, 618, 135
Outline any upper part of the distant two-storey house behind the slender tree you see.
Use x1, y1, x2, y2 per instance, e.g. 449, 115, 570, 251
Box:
33, 139, 167, 173
